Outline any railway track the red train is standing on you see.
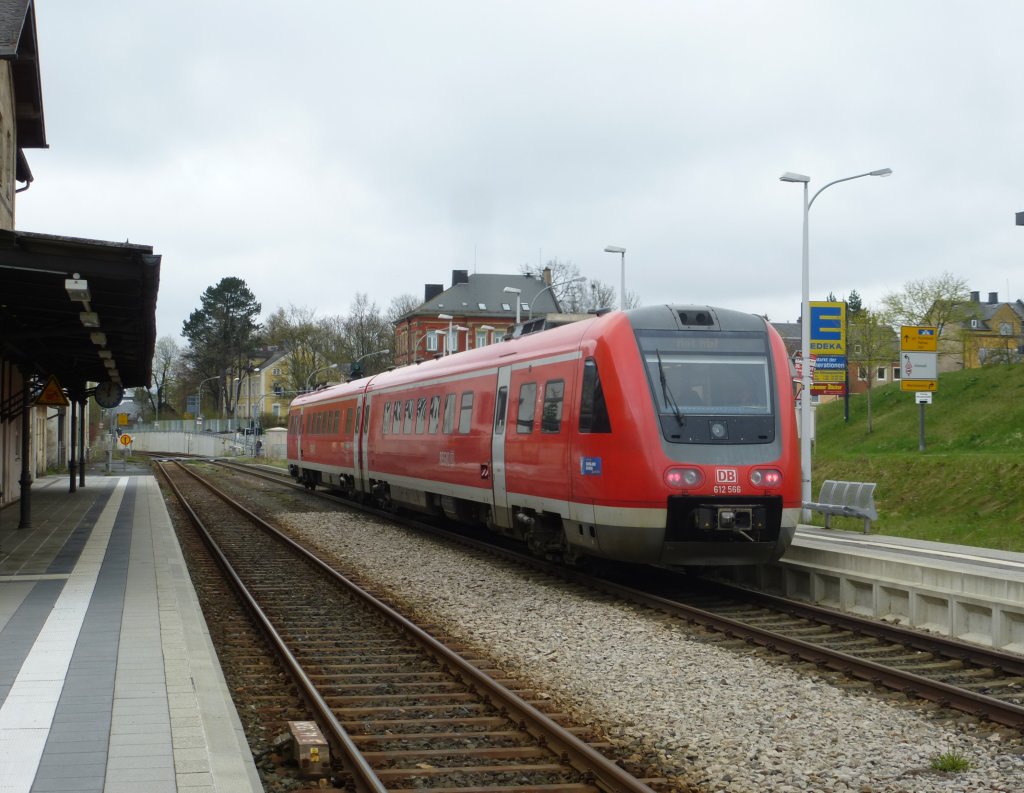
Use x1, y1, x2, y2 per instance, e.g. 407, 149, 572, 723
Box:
195, 458, 1024, 728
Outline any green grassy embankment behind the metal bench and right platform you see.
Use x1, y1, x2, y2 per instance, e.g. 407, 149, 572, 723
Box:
812, 365, 1024, 551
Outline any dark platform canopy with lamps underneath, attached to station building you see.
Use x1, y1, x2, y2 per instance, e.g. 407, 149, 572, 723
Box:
0, 231, 161, 393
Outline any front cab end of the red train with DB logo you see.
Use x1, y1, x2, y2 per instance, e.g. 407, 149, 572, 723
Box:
565, 305, 800, 568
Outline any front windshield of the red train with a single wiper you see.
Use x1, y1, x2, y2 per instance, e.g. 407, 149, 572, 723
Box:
637, 331, 774, 443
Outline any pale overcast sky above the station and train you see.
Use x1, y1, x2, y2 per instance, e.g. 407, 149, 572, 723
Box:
16, 0, 1024, 336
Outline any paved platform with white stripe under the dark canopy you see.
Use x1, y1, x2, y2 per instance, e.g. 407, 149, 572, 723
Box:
0, 465, 263, 793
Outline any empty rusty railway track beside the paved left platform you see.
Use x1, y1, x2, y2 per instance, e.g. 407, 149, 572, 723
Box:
158, 462, 658, 793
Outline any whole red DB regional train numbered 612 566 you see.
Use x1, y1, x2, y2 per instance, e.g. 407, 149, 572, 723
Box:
288, 305, 801, 569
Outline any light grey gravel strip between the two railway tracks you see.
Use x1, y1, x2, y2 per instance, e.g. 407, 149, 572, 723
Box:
279, 512, 1024, 793
